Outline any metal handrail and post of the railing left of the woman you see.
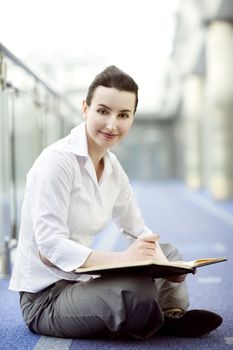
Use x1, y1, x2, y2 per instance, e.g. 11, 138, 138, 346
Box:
0, 43, 79, 277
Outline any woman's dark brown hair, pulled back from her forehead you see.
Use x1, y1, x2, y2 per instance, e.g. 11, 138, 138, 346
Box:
86, 66, 138, 113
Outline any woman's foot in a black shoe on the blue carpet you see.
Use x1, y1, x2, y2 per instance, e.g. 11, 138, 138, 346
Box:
158, 310, 222, 338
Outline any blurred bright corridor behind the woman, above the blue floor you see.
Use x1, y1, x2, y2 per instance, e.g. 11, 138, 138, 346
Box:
0, 0, 233, 349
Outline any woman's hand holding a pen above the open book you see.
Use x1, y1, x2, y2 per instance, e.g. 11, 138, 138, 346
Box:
122, 233, 159, 262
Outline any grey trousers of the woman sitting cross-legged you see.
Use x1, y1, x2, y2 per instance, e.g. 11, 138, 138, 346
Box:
20, 244, 188, 339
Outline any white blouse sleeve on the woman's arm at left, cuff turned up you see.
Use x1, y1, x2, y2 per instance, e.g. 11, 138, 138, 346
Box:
27, 151, 92, 272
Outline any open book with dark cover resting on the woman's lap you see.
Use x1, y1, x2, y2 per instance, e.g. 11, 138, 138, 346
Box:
75, 258, 227, 278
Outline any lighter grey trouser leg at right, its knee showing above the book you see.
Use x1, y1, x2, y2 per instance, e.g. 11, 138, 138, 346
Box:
155, 243, 189, 310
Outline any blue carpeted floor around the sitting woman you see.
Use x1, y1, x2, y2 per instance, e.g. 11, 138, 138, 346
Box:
0, 182, 233, 350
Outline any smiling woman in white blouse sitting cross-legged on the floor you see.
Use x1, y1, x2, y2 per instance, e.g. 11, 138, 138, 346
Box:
10, 66, 222, 338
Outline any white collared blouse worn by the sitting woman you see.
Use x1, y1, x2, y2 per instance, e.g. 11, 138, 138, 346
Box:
9, 123, 151, 292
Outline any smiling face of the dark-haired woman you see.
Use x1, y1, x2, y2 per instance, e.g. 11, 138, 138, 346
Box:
83, 86, 136, 150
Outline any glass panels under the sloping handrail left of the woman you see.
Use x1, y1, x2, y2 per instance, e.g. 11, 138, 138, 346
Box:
0, 46, 81, 274
